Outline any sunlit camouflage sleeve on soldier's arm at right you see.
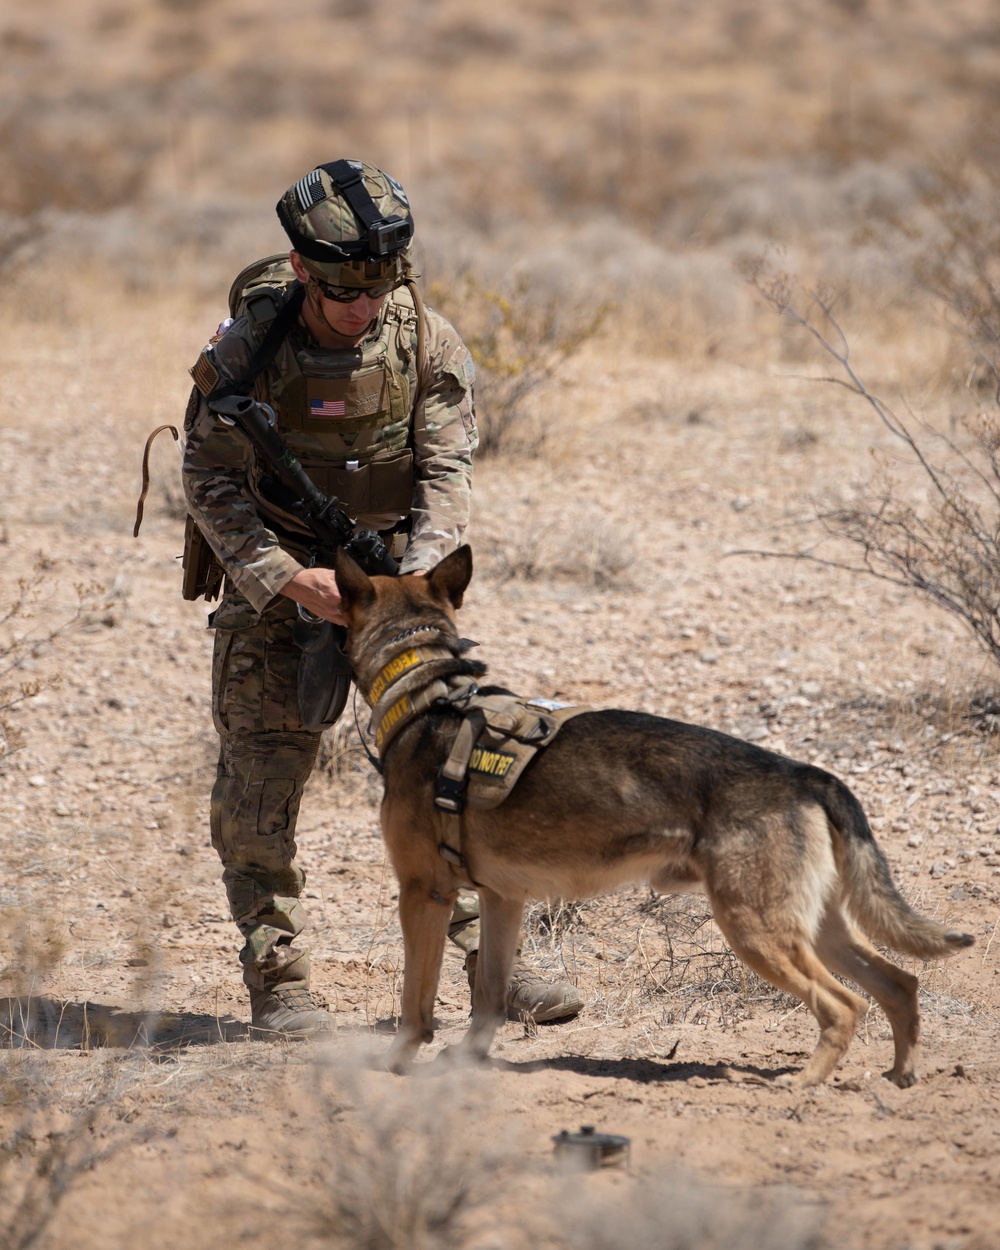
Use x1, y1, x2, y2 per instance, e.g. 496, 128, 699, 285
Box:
400, 309, 479, 573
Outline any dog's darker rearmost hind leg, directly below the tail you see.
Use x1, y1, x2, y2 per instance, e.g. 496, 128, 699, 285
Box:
816, 908, 920, 1089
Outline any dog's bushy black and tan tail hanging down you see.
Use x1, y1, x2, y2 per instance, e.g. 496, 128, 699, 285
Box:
820, 774, 975, 959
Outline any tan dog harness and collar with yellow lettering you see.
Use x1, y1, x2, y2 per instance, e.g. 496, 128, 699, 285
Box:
368, 628, 591, 885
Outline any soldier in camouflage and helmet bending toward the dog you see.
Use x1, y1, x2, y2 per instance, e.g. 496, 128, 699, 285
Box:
184, 160, 583, 1038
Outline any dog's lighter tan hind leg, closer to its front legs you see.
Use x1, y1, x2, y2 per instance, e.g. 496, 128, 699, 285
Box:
716, 909, 868, 1088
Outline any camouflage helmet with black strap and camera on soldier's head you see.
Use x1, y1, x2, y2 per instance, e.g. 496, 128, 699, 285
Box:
276, 160, 414, 288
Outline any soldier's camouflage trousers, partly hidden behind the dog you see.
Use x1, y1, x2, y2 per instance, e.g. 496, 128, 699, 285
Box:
211, 589, 479, 989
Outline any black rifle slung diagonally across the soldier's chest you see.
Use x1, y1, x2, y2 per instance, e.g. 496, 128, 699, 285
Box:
209, 395, 399, 578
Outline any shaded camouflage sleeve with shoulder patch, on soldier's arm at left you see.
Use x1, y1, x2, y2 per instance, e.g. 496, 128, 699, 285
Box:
183, 321, 301, 611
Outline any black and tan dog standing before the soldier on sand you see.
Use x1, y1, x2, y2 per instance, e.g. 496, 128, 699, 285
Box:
336, 546, 974, 1088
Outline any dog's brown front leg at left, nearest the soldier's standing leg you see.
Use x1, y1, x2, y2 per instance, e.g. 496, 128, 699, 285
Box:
386, 879, 455, 1073
